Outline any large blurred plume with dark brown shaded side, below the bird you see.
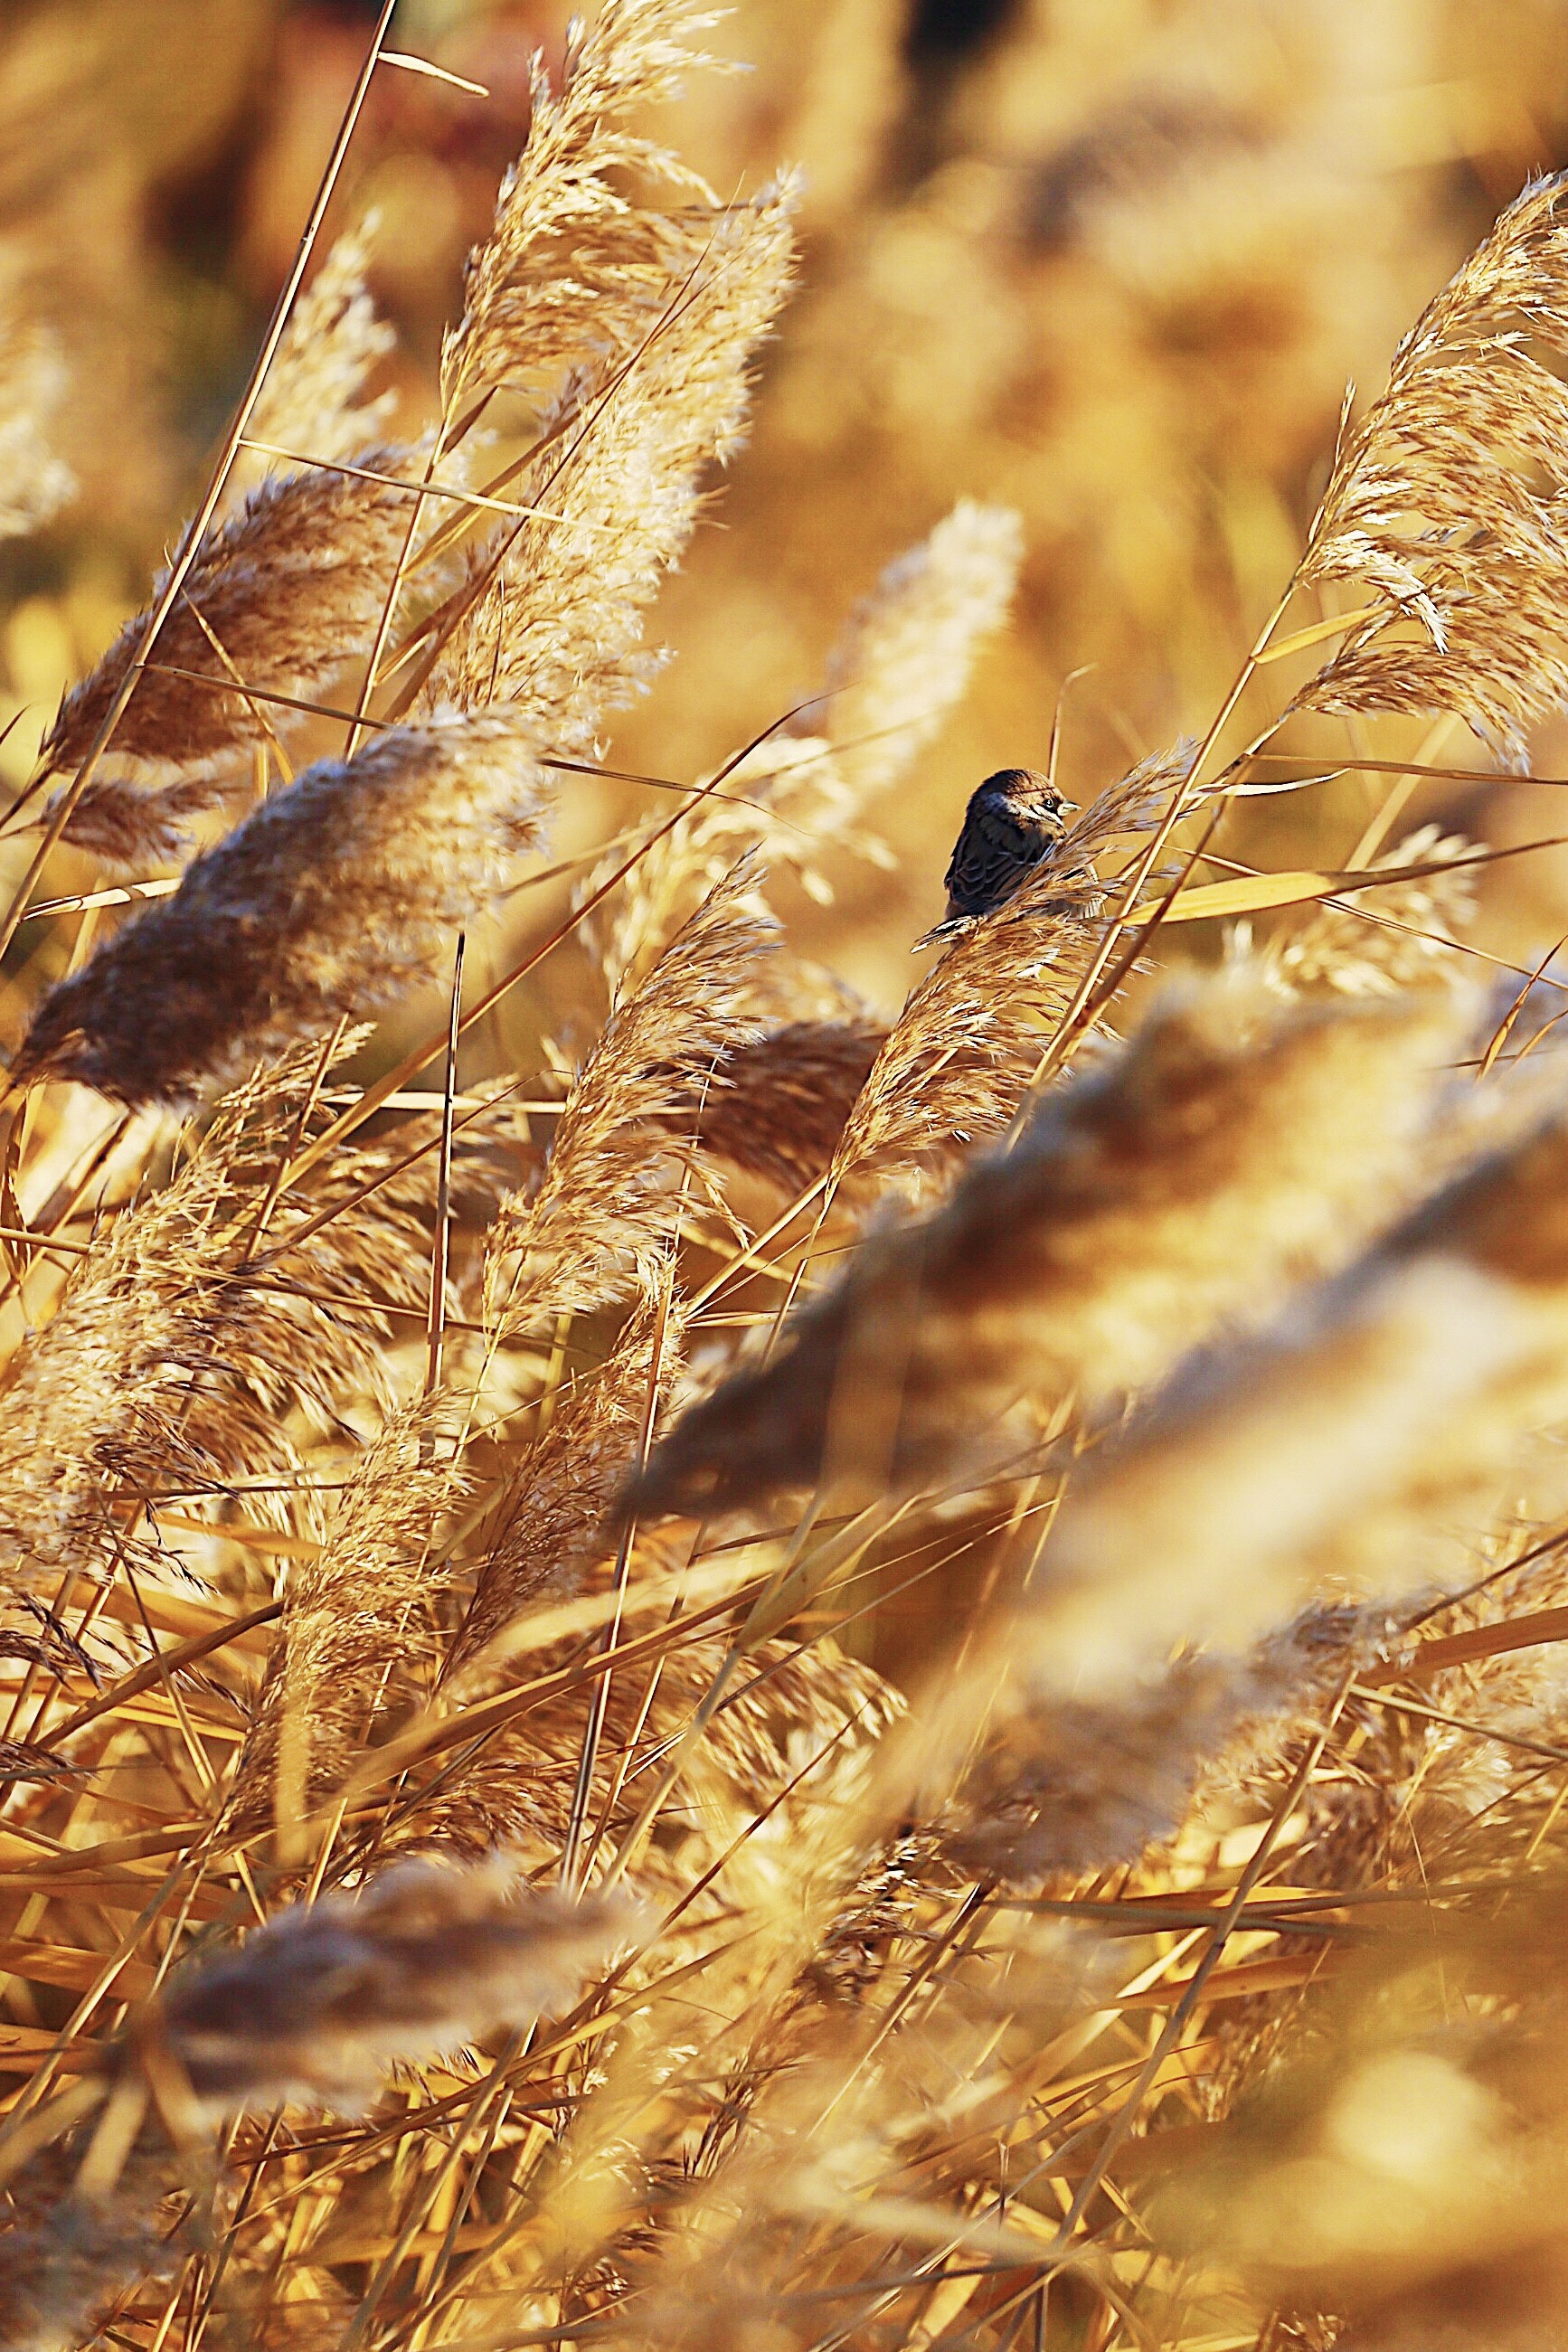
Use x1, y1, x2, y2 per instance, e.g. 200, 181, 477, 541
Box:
639, 964, 1458, 1507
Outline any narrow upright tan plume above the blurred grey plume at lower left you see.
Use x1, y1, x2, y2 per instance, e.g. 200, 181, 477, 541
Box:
228, 1409, 463, 1848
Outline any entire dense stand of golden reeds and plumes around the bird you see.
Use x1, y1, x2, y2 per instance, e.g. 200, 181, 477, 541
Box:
14, 0, 1568, 2352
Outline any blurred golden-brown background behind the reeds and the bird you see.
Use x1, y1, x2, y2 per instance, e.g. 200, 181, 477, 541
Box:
0, 0, 1568, 1011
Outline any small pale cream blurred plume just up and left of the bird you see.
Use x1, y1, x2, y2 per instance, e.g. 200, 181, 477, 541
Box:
813, 498, 1023, 798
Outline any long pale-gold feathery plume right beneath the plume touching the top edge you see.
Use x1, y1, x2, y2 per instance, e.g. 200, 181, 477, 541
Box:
420, 185, 792, 755
